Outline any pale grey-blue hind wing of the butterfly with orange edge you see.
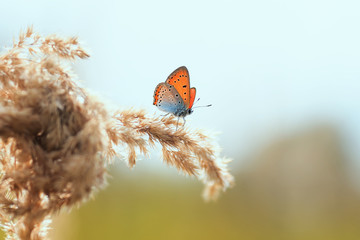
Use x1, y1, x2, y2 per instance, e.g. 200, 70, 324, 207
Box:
153, 83, 187, 116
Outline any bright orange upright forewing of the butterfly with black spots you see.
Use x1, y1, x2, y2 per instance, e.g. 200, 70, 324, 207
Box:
165, 66, 190, 109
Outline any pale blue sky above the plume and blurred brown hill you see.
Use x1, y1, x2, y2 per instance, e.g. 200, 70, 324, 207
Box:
0, 0, 360, 169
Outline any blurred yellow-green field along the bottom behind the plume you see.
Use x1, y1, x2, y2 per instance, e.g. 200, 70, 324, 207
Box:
48, 167, 360, 240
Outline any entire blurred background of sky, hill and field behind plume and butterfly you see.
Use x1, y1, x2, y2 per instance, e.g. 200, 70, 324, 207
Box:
0, 0, 360, 240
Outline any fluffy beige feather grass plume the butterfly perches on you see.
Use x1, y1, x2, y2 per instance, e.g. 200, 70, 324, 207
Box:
0, 28, 233, 239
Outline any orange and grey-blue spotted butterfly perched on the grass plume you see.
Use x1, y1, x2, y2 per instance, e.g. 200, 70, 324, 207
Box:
153, 66, 211, 124
